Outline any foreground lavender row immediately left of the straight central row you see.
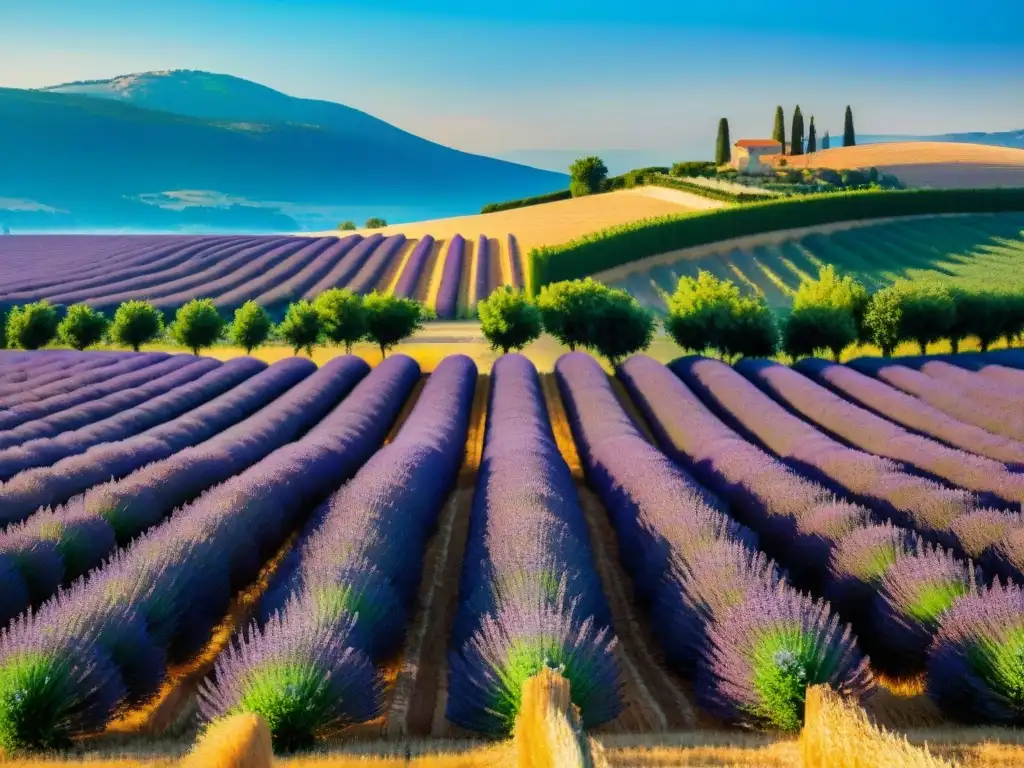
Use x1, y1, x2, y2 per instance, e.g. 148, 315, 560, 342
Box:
201, 355, 476, 751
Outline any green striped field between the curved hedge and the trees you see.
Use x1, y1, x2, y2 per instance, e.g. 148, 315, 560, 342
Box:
610, 213, 1024, 312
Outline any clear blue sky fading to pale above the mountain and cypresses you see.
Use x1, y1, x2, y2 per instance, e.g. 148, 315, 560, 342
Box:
0, 0, 1024, 157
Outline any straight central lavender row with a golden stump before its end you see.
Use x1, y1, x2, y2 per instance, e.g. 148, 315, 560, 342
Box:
446, 354, 622, 733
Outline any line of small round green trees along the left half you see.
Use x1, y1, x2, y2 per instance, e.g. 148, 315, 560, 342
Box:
4, 289, 431, 356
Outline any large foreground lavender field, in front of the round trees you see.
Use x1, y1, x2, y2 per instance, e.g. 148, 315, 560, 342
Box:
0, 350, 1024, 765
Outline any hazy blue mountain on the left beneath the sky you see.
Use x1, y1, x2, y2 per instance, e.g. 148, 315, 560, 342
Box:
0, 71, 568, 231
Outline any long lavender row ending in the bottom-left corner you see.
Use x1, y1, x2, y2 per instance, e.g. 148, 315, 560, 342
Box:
0, 356, 419, 744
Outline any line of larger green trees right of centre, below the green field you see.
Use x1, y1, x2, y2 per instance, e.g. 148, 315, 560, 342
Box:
479, 266, 1024, 365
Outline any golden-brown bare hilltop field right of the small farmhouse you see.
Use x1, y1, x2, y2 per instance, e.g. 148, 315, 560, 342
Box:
775, 141, 1024, 188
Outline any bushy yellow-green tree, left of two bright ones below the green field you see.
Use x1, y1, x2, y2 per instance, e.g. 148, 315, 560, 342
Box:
665, 269, 778, 357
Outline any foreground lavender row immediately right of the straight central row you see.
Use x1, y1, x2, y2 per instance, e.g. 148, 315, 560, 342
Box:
555, 353, 872, 730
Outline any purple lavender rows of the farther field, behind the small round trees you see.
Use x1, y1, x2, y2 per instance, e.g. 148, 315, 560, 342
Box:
0, 233, 522, 317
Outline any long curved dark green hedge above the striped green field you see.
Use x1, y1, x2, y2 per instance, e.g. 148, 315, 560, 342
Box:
528, 188, 1024, 294
